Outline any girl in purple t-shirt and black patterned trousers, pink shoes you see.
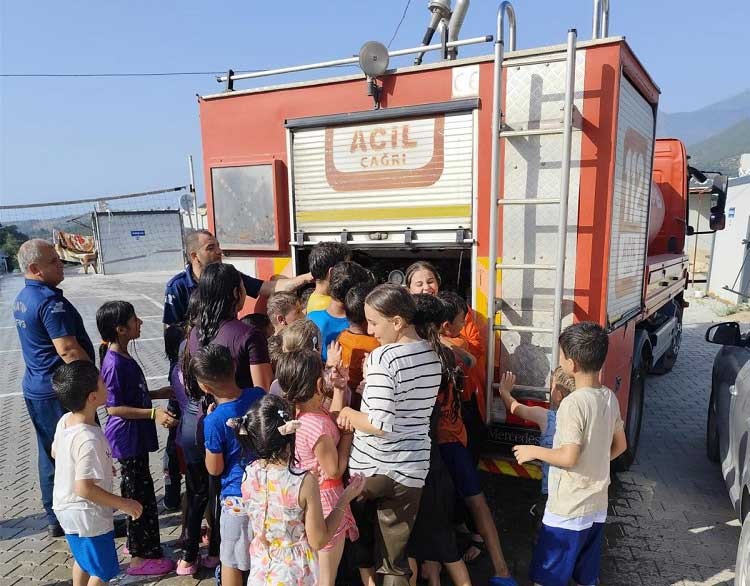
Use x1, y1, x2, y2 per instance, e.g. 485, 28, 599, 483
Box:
96, 301, 177, 576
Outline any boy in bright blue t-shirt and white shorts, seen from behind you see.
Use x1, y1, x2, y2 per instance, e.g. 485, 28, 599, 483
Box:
190, 344, 266, 586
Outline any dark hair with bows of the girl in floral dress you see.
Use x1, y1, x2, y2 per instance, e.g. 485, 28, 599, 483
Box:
227, 394, 296, 473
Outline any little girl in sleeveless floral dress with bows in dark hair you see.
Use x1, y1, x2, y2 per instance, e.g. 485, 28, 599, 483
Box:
230, 395, 364, 586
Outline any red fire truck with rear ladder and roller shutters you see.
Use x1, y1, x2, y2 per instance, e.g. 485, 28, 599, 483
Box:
199, 0, 722, 475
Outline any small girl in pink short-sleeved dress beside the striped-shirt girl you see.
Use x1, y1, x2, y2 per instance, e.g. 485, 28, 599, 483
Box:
276, 350, 359, 586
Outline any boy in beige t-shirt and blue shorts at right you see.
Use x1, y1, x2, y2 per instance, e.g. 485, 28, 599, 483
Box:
513, 322, 627, 586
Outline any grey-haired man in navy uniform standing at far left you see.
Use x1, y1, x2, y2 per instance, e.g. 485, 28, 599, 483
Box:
13, 239, 94, 537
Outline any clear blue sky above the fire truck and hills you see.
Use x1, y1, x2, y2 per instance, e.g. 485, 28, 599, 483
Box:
0, 0, 750, 205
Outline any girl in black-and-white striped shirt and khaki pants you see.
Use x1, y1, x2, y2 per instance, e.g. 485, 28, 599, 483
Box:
338, 284, 442, 586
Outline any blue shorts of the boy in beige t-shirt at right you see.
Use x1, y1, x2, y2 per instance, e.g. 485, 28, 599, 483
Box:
529, 523, 604, 586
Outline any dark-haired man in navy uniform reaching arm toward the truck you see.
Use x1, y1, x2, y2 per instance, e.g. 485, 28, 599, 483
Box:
162, 230, 312, 326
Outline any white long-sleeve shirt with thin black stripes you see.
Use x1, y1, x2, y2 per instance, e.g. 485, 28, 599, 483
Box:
349, 341, 441, 487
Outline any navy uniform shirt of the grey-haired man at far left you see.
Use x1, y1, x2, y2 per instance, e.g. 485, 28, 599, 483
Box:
13, 279, 94, 399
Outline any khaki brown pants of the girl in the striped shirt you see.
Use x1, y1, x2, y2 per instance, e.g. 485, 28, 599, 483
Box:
362, 474, 422, 586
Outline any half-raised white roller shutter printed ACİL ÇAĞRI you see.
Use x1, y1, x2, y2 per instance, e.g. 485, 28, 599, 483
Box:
291, 110, 475, 247
